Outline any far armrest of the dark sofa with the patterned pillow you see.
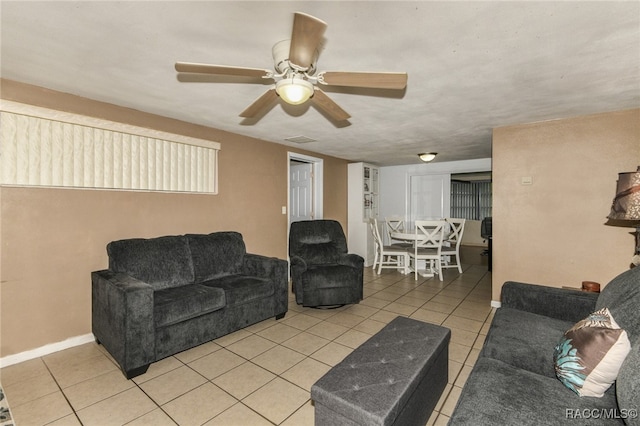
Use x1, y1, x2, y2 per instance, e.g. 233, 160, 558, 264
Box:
501, 281, 598, 322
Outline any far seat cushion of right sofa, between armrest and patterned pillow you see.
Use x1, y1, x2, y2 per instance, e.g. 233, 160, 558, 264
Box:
481, 308, 573, 380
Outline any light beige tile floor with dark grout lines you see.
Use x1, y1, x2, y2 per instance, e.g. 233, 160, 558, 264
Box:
0, 248, 493, 426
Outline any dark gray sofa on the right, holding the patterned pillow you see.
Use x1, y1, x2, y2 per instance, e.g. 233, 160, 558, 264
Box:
449, 267, 640, 426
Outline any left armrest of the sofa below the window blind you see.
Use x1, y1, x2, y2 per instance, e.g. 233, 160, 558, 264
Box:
91, 270, 155, 377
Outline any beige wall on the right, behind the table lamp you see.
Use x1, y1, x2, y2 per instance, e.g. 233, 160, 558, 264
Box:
493, 109, 640, 301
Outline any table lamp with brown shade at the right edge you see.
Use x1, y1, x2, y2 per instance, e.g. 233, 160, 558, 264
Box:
607, 167, 640, 266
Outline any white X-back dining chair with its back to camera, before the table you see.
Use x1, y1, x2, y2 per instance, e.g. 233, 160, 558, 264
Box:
409, 220, 447, 281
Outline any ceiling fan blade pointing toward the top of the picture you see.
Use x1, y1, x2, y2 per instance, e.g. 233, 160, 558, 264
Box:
289, 12, 327, 68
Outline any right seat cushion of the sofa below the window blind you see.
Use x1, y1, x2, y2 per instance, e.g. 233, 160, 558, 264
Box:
203, 275, 274, 306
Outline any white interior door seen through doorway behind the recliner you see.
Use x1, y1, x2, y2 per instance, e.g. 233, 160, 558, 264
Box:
289, 163, 314, 223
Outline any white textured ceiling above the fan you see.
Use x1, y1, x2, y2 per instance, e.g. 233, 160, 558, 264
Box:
0, 1, 640, 165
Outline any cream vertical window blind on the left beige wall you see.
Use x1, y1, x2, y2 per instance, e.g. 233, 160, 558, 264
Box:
0, 103, 219, 194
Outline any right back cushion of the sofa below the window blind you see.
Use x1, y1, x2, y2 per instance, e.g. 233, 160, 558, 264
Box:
186, 231, 247, 282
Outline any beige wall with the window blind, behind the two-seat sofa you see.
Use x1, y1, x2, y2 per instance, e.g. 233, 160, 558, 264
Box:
0, 80, 347, 357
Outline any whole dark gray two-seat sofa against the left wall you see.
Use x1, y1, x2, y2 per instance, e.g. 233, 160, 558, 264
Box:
91, 232, 288, 378
